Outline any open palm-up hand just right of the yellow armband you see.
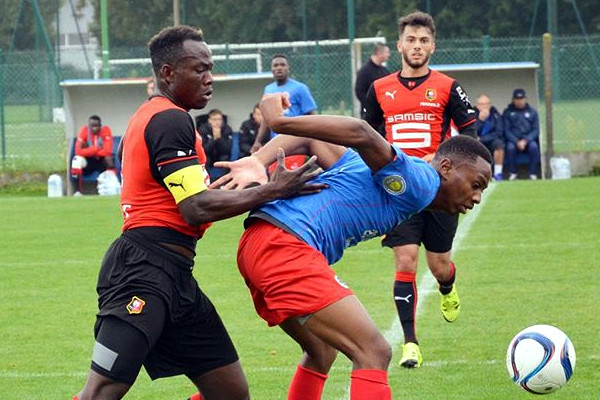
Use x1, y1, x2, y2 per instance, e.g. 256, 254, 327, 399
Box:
210, 156, 269, 190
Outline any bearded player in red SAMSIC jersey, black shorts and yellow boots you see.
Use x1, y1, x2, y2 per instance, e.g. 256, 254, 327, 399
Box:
365, 12, 477, 368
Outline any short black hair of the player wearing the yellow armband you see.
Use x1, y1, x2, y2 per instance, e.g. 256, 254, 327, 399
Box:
148, 25, 204, 76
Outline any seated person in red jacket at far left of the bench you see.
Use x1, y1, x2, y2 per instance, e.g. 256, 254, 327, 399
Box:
71, 115, 116, 194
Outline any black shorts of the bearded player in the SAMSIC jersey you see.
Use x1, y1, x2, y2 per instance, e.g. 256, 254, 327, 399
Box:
381, 210, 458, 253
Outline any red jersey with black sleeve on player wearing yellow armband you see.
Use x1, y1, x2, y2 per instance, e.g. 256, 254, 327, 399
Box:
121, 96, 210, 239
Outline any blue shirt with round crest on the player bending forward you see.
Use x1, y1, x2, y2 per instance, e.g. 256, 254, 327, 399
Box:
258, 147, 440, 264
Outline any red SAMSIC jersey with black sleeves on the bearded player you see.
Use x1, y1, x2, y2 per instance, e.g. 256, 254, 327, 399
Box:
365, 70, 476, 157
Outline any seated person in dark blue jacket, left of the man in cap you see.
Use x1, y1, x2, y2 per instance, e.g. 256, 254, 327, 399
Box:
475, 94, 504, 181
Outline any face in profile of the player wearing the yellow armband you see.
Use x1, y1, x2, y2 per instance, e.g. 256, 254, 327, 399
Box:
165, 40, 213, 110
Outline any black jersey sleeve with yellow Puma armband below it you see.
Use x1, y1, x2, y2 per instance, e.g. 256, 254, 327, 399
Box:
145, 109, 207, 203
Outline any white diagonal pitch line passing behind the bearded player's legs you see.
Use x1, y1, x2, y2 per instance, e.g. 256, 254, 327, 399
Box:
339, 183, 496, 400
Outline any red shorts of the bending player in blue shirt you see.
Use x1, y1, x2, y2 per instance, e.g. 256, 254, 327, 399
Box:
237, 220, 353, 326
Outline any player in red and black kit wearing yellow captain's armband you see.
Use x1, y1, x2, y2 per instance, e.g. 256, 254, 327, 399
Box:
74, 26, 324, 400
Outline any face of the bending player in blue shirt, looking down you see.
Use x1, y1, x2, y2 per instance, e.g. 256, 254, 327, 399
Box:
440, 157, 492, 214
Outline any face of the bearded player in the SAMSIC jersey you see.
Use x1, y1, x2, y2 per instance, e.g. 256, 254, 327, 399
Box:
398, 25, 435, 69
